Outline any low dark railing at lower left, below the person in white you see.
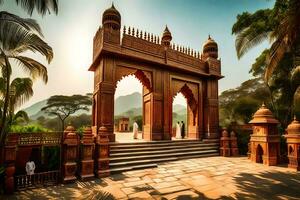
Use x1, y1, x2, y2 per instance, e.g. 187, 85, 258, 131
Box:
15, 170, 61, 190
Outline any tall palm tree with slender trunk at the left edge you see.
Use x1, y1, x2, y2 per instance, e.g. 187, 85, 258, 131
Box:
0, 16, 53, 144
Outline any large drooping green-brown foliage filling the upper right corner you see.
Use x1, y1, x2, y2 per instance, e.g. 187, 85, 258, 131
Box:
232, 0, 300, 80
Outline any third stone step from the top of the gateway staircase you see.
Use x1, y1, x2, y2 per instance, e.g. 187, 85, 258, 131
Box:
110, 145, 219, 158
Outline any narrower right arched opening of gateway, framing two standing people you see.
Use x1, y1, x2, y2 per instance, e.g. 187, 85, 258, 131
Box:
172, 92, 188, 140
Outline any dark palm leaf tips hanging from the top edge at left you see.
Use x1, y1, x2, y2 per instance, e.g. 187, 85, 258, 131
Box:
0, 0, 58, 16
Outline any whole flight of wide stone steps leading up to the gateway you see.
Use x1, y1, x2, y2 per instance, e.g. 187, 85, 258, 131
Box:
109, 139, 219, 173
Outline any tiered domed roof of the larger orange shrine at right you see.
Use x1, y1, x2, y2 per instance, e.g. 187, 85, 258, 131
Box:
249, 103, 279, 124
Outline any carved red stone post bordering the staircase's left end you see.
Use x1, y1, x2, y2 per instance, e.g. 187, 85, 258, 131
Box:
95, 126, 109, 177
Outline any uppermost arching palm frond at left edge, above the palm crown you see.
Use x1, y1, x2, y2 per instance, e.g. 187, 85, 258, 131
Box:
0, 11, 43, 36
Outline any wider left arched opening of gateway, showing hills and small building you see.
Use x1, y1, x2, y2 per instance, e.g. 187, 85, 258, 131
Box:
114, 74, 143, 142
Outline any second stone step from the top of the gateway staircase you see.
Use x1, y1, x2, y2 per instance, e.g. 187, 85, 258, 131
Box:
110, 143, 219, 155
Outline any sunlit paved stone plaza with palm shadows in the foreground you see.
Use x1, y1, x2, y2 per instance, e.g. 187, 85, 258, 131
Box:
8, 157, 300, 200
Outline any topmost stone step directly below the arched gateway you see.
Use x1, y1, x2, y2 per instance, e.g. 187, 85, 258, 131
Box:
110, 141, 219, 150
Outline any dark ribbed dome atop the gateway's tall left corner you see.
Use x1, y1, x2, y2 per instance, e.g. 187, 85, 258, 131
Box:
102, 4, 121, 30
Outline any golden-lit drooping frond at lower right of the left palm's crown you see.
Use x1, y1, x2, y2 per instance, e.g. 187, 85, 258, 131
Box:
11, 56, 48, 83
